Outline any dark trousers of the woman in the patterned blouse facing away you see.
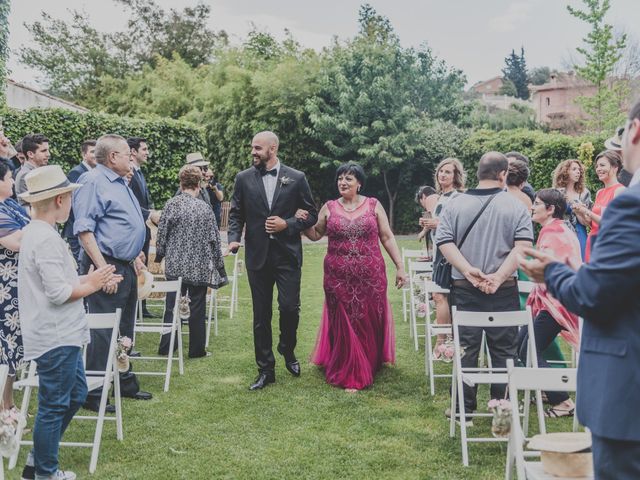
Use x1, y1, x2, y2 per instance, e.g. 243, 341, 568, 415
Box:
158, 278, 207, 358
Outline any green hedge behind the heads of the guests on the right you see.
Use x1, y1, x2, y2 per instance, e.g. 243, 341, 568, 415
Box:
459, 129, 606, 194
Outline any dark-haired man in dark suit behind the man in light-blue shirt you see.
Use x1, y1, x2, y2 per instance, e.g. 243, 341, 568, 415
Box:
127, 137, 160, 318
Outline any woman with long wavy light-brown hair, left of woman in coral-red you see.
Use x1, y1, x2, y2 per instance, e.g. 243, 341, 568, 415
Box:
553, 158, 592, 261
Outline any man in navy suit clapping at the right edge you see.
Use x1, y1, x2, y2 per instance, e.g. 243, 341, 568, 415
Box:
520, 102, 640, 480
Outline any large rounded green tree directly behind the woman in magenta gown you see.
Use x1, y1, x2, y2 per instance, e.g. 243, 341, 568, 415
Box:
307, 5, 466, 229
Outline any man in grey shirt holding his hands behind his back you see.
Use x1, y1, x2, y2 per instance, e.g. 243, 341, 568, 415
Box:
435, 152, 533, 423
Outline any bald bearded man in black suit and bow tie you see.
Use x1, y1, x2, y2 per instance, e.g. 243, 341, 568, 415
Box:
228, 132, 318, 390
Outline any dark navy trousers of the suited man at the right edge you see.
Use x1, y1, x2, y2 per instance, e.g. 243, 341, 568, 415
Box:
591, 433, 640, 480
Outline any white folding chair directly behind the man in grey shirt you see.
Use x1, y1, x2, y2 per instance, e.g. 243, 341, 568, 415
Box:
449, 306, 545, 467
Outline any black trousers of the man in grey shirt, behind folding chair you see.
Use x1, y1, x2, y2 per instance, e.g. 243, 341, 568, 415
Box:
451, 283, 520, 412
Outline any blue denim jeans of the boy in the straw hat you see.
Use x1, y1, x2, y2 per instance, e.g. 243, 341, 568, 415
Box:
33, 347, 87, 478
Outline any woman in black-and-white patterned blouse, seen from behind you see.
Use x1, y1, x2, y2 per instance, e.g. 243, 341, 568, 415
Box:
155, 165, 228, 358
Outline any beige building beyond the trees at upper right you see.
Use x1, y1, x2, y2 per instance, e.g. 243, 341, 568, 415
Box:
529, 72, 596, 131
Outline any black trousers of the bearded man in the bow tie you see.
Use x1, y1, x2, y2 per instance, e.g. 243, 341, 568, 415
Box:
247, 240, 301, 373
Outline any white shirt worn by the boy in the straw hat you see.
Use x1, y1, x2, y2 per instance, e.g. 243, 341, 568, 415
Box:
18, 220, 90, 360
